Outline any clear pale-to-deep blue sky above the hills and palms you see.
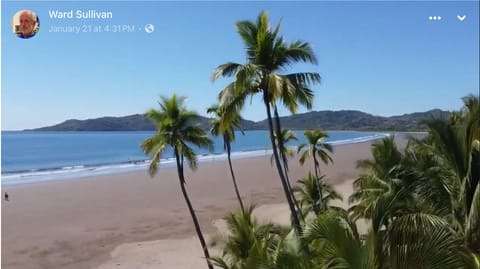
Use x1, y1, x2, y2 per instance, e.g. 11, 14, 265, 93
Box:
1, 1, 479, 130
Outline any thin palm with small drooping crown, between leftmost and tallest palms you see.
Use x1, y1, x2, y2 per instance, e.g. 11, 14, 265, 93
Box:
207, 106, 245, 211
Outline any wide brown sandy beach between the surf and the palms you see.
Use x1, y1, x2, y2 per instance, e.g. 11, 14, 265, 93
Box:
2, 139, 382, 269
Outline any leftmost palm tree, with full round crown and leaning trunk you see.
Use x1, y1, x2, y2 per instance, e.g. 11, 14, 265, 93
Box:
142, 94, 213, 269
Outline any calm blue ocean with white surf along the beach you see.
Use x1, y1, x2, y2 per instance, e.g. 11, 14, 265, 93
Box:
1, 131, 386, 186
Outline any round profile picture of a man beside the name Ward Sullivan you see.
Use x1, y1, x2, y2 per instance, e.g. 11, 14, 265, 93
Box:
12, 10, 40, 39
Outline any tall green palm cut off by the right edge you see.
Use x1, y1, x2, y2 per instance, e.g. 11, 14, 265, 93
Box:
424, 95, 480, 256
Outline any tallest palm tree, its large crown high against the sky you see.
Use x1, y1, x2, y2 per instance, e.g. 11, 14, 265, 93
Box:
212, 12, 320, 231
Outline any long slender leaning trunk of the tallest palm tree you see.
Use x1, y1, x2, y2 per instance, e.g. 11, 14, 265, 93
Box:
263, 98, 301, 232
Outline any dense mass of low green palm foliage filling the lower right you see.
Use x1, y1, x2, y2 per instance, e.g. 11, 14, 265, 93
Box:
213, 96, 480, 269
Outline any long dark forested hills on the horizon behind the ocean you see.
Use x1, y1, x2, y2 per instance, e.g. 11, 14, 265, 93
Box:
32, 109, 450, 131
